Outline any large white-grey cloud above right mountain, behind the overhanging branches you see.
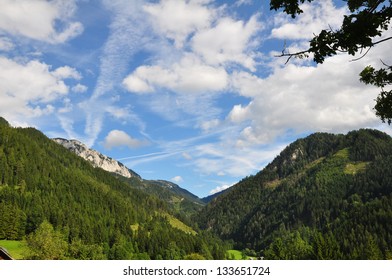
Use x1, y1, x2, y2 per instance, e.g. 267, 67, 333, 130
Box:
219, 1, 389, 148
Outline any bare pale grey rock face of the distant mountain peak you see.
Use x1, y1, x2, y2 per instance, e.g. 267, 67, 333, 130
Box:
53, 138, 140, 178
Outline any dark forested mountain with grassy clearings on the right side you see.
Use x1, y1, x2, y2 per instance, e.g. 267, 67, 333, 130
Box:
198, 129, 392, 259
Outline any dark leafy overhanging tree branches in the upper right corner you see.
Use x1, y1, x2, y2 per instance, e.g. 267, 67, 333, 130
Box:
270, 0, 392, 125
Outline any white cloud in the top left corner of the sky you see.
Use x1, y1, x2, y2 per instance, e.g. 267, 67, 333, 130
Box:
0, 0, 83, 43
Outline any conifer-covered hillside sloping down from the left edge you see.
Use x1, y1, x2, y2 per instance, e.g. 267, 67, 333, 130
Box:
0, 118, 226, 259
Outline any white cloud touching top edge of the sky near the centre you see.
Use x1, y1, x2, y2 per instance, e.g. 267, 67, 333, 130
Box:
144, 0, 214, 48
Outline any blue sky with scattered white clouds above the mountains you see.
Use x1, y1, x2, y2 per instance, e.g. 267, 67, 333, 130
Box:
0, 0, 391, 197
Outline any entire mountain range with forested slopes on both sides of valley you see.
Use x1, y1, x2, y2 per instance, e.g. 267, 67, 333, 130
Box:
0, 115, 392, 259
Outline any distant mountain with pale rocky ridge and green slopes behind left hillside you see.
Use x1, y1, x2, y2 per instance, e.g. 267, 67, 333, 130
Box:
53, 138, 205, 214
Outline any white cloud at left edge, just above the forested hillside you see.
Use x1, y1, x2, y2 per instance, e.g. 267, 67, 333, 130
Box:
0, 57, 79, 122
